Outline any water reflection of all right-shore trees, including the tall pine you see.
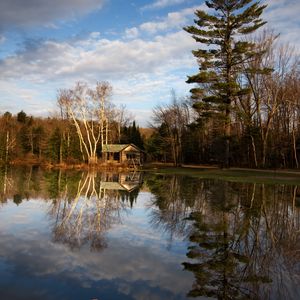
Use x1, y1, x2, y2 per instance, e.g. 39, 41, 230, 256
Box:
147, 175, 300, 299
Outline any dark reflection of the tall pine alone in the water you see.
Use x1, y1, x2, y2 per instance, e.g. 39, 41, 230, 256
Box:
183, 183, 269, 299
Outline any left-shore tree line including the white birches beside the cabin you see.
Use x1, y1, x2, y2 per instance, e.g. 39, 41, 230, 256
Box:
0, 82, 144, 165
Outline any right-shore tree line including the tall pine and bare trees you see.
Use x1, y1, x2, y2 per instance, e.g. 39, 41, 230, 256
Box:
148, 0, 300, 168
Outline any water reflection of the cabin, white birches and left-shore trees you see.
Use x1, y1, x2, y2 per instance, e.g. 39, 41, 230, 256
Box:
0, 167, 142, 251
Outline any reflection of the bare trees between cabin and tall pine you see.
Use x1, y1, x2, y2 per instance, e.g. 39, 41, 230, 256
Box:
146, 175, 207, 247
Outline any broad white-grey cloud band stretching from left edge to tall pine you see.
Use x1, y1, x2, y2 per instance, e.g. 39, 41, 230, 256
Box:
0, 31, 194, 83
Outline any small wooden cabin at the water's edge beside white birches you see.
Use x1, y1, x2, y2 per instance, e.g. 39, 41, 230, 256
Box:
102, 144, 143, 168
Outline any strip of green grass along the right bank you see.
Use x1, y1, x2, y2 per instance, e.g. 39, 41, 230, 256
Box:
145, 166, 300, 185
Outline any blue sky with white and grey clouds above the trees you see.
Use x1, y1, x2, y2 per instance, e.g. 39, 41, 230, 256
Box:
0, 0, 300, 126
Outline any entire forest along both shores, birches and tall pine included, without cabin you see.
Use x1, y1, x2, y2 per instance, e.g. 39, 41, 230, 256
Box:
0, 0, 300, 168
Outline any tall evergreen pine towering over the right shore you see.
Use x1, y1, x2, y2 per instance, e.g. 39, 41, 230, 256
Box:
184, 0, 266, 167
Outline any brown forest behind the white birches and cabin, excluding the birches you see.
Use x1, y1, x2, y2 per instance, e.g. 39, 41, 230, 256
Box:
0, 103, 143, 166
